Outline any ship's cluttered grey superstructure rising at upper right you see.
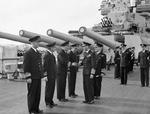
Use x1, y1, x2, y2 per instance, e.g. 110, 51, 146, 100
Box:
93, 0, 150, 45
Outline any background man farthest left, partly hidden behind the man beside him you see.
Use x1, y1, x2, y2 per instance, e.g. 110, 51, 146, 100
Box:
114, 46, 120, 78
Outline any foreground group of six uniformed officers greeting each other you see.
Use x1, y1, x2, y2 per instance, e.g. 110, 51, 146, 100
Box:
23, 36, 106, 114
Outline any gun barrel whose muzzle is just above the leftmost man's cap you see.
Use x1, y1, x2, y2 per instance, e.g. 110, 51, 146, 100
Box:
19, 30, 65, 45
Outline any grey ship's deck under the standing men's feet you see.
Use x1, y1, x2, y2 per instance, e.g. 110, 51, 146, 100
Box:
0, 66, 150, 114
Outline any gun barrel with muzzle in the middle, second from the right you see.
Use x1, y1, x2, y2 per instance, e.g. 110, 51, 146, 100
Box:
47, 29, 83, 44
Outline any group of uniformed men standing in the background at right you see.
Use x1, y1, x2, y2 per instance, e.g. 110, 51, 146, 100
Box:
114, 44, 150, 87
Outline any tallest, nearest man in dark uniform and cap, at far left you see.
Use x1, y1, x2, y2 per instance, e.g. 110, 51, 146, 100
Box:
23, 36, 43, 114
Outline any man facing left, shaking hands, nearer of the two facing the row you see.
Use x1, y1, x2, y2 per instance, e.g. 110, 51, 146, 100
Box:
81, 42, 95, 104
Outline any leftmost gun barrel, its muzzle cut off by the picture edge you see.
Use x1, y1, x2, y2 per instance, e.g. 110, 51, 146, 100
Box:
0, 32, 47, 47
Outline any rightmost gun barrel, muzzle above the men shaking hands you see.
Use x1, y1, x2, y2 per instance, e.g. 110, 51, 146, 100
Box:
79, 27, 118, 49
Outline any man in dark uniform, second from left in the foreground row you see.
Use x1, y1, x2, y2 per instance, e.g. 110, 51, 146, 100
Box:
43, 43, 57, 108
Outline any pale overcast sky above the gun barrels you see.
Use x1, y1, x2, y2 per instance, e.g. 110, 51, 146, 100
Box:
0, 0, 101, 43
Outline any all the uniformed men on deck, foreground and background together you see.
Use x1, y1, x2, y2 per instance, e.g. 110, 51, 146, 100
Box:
23, 36, 150, 114
